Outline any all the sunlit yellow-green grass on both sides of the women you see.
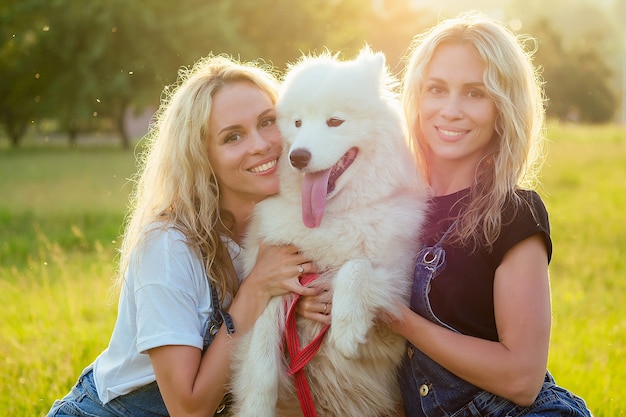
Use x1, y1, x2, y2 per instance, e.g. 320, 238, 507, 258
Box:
0, 125, 626, 417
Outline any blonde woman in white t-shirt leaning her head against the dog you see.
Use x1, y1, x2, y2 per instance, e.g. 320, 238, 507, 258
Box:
48, 56, 316, 417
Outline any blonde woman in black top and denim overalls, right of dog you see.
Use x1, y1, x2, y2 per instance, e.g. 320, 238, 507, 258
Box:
391, 13, 590, 417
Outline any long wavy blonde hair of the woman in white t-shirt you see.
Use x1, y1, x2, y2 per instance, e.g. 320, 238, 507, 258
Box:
117, 56, 278, 301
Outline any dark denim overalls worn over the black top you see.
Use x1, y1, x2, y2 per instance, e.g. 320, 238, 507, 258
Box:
400, 222, 591, 417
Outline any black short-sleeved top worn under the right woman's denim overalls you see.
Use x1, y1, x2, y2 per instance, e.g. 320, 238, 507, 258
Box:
422, 189, 552, 341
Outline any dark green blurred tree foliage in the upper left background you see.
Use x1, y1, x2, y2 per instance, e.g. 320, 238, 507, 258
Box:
0, 0, 241, 148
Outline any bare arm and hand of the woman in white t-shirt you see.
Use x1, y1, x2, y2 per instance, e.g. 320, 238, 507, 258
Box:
148, 245, 317, 417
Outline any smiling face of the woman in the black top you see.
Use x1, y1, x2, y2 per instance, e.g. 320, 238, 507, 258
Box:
418, 43, 497, 169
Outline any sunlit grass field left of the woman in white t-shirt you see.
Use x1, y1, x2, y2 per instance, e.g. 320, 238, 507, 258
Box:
0, 139, 136, 416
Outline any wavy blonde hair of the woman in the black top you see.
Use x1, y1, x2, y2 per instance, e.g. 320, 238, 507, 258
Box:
403, 12, 545, 249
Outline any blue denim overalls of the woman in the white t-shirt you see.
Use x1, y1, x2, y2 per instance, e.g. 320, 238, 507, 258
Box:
47, 284, 234, 417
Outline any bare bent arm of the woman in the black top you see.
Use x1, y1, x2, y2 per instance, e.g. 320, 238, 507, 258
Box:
391, 234, 551, 406
